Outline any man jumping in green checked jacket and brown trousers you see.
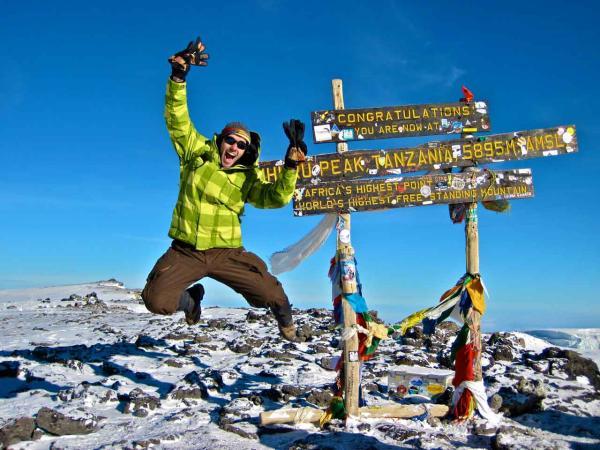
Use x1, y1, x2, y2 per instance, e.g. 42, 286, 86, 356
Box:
142, 38, 307, 341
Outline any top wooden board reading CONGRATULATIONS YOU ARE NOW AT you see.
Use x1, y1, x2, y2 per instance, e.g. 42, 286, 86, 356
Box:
311, 101, 490, 144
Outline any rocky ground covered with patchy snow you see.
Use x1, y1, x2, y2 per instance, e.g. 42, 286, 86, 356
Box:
0, 280, 600, 450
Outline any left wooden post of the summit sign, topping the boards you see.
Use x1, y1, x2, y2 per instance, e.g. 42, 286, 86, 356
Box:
331, 79, 360, 416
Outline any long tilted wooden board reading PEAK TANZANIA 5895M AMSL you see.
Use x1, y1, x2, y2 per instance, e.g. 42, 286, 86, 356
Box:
260, 125, 578, 185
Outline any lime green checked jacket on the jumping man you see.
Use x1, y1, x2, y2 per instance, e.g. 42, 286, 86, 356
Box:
165, 79, 297, 250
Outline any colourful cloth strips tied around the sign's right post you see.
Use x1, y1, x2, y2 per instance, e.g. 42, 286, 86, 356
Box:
392, 273, 492, 420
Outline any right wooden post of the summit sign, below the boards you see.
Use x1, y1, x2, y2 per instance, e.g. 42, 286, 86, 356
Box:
465, 196, 483, 381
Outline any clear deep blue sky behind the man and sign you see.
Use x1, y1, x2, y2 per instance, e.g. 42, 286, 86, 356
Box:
0, 0, 600, 330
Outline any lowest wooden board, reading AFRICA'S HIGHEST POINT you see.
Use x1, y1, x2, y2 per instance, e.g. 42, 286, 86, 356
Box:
294, 169, 533, 216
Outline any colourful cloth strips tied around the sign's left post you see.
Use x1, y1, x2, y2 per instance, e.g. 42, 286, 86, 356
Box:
321, 257, 394, 426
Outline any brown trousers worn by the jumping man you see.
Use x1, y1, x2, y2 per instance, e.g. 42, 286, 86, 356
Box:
142, 240, 292, 326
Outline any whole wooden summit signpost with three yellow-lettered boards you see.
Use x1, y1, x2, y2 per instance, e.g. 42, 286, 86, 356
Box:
260, 80, 578, 424
